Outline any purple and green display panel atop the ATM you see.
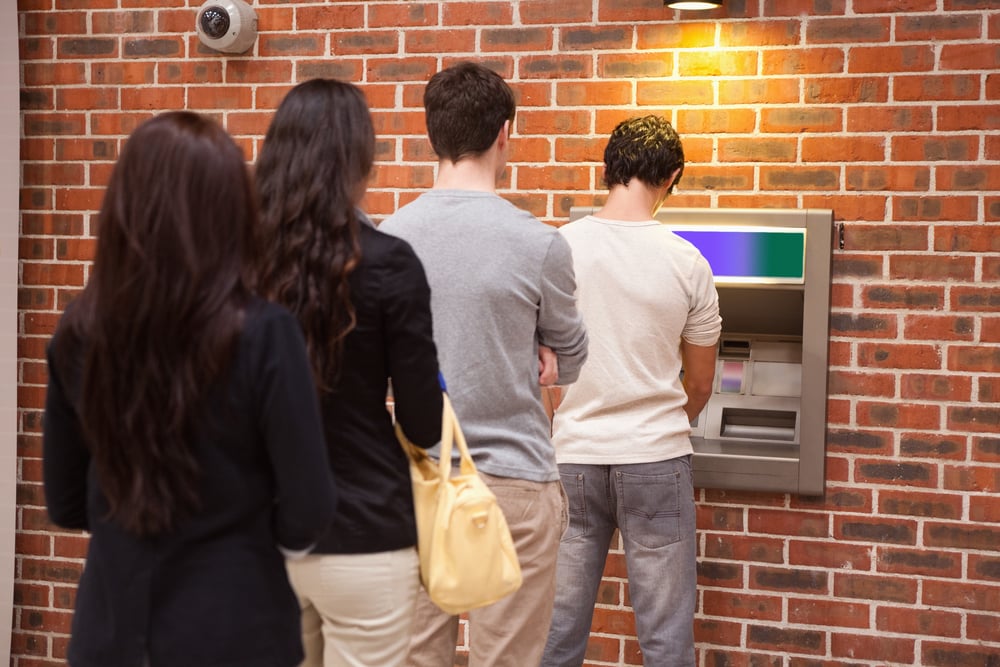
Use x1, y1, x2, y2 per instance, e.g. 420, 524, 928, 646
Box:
672, 226, 806, 283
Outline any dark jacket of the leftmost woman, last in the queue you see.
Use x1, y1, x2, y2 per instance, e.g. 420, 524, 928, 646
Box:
43, 301, 336, 667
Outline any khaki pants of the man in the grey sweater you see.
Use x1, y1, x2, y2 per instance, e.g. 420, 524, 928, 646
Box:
406, 472, 566, 667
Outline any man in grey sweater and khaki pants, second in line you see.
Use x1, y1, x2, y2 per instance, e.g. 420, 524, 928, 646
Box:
380, 62, 587, 667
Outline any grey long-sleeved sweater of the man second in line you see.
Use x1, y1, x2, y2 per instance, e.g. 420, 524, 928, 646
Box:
379, 190, 587, 482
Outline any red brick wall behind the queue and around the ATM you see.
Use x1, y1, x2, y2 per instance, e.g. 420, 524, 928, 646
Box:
11, 0, 1000, 667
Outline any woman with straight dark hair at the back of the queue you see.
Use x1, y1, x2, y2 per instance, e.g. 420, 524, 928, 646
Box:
44, 112, 336, 667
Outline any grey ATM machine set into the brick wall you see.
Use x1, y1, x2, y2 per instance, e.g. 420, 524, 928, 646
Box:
570, 207, 833, 495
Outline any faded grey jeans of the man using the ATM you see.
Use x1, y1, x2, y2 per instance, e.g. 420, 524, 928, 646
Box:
542, 456, 697, 667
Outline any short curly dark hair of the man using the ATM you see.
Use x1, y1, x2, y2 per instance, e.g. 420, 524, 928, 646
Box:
604, 115, 684, 191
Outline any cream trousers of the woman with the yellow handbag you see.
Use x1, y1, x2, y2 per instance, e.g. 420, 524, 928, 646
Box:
287, 547, 420, 667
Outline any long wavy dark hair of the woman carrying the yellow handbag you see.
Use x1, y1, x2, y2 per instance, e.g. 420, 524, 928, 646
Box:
256, 79, 375, 389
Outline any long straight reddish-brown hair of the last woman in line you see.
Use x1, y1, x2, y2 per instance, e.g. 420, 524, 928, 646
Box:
54, 112, 256, 536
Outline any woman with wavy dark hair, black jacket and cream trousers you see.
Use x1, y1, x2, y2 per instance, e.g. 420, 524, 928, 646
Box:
256, 79, 441, 667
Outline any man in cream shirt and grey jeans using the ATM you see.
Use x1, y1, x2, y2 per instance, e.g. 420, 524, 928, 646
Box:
542, 116, 722, 667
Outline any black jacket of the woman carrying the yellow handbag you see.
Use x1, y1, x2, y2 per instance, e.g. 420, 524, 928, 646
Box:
316, 225, 441, 553
